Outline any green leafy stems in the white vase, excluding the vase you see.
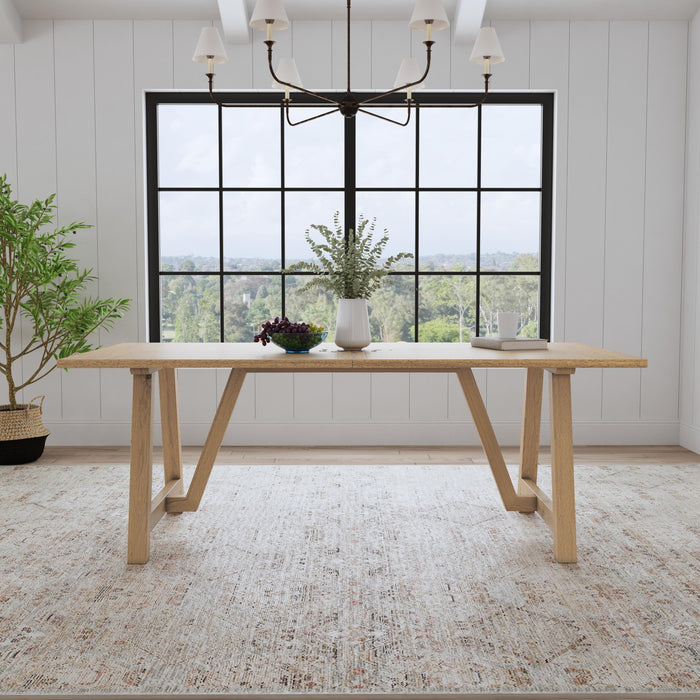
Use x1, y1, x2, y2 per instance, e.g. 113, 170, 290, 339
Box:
283, 212, 413, 299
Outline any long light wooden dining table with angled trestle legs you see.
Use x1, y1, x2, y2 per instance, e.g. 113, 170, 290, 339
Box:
58, 343, 647, 564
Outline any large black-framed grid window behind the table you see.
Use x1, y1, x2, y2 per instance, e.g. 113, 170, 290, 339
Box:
146, 92, 554, 342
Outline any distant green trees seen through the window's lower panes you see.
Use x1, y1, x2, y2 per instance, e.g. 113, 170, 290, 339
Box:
161, 253, 539, 343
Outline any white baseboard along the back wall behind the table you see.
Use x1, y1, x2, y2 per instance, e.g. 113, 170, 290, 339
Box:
42, 420, 680, 452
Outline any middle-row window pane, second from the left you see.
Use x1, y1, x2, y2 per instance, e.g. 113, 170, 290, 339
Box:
224, 192, 281, 270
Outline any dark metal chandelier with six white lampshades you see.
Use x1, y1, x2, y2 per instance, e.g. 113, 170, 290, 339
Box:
193, 0, 505, 126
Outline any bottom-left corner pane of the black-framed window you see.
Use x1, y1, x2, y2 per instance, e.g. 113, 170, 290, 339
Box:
160, 275, 221, 343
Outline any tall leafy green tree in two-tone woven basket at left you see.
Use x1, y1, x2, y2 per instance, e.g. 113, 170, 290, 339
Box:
0, 175, 130, 464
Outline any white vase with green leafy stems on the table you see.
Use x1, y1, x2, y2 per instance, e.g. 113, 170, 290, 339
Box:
284, 212, 413, 350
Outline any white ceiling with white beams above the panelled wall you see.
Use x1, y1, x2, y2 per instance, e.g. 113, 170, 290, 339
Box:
0, 0, 700, 42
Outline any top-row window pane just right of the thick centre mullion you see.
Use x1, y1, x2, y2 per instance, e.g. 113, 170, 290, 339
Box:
355, 105, 416, 187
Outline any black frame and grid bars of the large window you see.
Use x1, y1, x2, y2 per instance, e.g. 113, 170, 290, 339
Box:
146, 93, 554, 342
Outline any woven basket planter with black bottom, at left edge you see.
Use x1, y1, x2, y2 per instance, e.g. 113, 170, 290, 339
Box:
0, 396, 49, 464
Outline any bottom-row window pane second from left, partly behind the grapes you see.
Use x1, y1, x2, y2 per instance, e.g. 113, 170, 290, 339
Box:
224, 275, 282, 343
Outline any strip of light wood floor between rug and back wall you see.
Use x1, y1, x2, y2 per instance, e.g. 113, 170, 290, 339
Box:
35, 445, 700, 465
